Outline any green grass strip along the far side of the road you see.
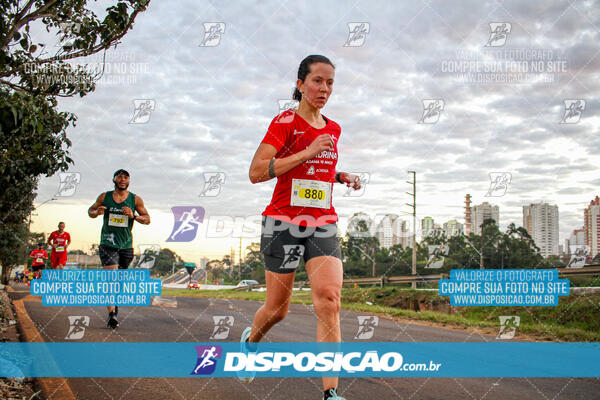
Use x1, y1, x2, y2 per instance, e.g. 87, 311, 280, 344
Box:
163, 286, 600, 342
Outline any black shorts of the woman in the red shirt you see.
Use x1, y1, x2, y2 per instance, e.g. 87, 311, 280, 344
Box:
260, 216, 342, 274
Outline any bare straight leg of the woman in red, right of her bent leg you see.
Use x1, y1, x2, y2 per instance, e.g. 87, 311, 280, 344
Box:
306, 256, 344, 390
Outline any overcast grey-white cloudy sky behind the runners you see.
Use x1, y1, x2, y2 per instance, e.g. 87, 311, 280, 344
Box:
32, 1, 600, 261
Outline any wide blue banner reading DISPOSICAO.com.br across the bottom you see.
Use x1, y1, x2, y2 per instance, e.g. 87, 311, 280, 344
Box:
0, 342, 600, 378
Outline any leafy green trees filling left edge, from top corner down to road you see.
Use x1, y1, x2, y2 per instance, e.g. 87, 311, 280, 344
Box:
0, 0, 149, 284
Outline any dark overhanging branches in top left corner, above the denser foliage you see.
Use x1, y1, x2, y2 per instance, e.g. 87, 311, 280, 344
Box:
0, 0, 149, 97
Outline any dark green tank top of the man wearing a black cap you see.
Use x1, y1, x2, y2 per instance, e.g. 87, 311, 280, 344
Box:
100, 190, 135, 249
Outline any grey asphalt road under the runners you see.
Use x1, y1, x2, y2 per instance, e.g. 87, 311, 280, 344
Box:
5, 285, 600, 400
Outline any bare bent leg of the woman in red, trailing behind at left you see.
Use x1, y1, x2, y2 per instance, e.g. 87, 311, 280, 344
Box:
248, 270, 296, 342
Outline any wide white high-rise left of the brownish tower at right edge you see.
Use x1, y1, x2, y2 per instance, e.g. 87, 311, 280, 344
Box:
523, 202, 559, 257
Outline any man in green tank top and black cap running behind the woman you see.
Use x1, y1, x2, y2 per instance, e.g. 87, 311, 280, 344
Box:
88, 169, 150, 329
